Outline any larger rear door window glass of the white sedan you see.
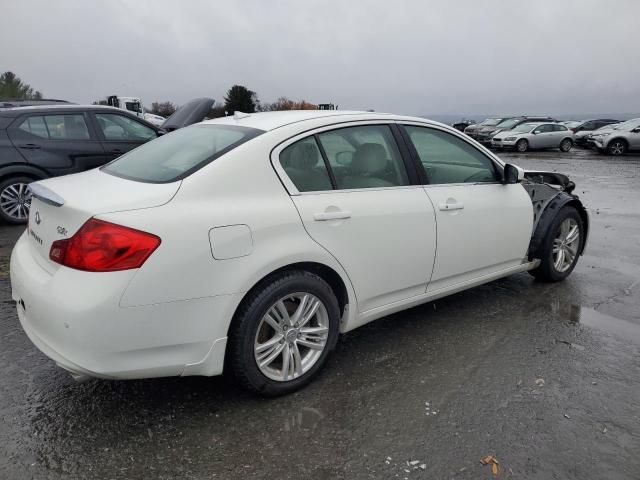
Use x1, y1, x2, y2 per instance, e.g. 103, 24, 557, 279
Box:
318, 125, 409, 189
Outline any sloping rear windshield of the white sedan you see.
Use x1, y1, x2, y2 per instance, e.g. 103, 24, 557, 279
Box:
102, 125, 264, 183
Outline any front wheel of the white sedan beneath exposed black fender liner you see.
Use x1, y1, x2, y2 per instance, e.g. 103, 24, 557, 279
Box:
529, 206, 584, 282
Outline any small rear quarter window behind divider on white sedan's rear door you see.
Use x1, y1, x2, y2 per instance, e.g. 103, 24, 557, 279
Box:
280, 137, 333, 192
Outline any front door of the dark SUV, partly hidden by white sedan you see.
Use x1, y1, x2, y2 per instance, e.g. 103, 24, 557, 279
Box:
91, 110, 158, 163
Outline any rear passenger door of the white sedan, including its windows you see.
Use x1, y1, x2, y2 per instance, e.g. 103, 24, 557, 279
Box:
273, 123, 436, 312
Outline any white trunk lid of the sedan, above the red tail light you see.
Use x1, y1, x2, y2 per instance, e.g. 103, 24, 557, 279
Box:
28, 169, 181, 271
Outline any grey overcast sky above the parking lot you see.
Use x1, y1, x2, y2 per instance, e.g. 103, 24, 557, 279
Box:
0, 0, 640, 115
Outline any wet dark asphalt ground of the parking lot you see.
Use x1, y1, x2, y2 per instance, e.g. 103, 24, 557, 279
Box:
0, 150, 640, 480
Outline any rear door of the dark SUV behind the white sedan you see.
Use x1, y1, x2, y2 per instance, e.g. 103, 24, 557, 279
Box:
7, 110, 104, 176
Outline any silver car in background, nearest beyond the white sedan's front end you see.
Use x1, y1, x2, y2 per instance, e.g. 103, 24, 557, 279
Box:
491, 122, 573, 152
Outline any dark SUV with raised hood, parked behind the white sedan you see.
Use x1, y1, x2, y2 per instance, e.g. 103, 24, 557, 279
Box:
0, 99, 213, 223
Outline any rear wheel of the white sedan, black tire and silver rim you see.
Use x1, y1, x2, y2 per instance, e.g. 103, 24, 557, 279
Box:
227, 270, 340, 396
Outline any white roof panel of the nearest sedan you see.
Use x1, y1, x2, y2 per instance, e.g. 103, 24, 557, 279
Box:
202, 110, 440, 131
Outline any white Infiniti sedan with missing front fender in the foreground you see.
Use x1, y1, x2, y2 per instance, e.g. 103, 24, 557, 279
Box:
11, 111, 589, 395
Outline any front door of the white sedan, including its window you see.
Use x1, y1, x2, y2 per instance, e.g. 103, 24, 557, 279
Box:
403, 124, 533, 292
